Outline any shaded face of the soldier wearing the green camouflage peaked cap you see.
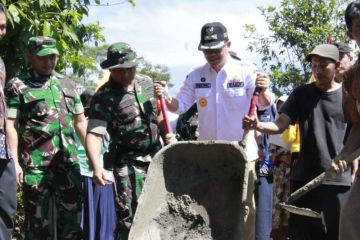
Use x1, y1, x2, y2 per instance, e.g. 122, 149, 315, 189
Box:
28, 53, 57, 76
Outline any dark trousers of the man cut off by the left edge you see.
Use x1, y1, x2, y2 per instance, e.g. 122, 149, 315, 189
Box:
0, 159, 17, 240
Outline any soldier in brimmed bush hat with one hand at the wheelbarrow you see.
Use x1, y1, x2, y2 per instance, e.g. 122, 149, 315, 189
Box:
86, 42, 175, 240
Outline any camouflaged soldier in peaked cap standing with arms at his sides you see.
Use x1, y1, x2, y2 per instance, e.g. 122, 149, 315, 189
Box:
6, 36, 87, 239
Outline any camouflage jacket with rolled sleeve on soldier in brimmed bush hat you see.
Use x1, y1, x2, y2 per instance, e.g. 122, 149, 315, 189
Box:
88, 75, 159, 164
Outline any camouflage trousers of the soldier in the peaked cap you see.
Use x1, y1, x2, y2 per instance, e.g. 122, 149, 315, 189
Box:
23, 163, 82, 240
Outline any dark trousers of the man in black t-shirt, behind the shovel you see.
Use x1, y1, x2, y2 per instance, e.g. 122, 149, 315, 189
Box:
289, 181, 350, 240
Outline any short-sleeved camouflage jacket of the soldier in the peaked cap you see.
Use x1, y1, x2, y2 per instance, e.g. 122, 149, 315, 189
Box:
5, 72, 84, 167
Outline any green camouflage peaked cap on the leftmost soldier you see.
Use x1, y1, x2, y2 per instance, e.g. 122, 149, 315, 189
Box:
28, 36, 59, 57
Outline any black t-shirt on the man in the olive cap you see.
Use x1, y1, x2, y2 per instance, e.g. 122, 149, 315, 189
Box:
279, 83, 350, 185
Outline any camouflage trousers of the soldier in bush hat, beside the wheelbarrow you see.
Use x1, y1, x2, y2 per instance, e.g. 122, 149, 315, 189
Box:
114, 161, 149, 240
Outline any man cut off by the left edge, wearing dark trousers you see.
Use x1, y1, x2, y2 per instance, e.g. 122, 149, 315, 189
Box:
0, 3, 16, 240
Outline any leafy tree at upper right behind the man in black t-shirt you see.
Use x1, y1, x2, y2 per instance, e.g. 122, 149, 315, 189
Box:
244, 0, 350, 94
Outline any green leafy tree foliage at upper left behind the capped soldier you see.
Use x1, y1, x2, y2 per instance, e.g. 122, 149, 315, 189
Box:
0, 0, 105, 78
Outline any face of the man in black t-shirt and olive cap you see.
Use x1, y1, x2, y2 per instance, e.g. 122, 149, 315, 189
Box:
311, 55, 339, 85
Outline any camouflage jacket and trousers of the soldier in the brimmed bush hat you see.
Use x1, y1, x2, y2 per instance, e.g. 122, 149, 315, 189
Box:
88, 75, 160, 239
